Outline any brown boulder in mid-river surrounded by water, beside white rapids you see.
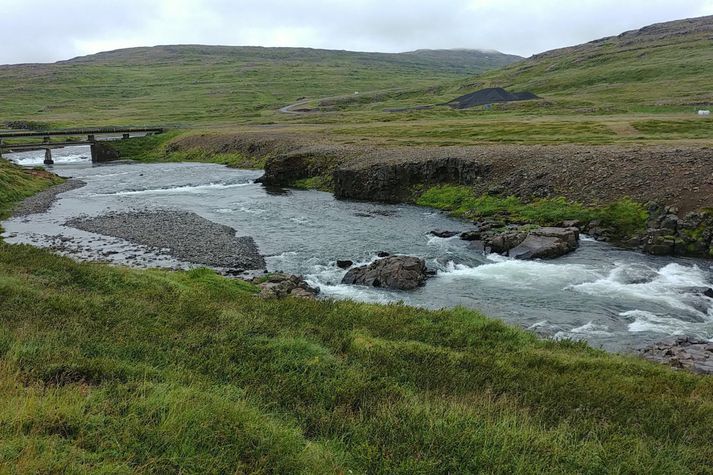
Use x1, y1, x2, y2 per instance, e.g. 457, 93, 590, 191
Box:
342, 256, 427, 290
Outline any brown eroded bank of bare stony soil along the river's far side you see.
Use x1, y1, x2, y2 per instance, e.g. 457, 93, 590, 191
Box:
163, 131, 713, 257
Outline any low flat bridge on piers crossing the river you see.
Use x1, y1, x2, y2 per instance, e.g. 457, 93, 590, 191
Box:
0, 127, 164, 165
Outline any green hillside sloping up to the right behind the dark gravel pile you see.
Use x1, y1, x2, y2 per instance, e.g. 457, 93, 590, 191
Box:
340, 16, 713, 113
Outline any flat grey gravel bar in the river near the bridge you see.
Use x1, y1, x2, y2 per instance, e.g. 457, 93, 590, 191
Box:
66, 210, 265, 270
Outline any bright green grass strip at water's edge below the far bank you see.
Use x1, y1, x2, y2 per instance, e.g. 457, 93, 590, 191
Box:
416, 185, 648, 238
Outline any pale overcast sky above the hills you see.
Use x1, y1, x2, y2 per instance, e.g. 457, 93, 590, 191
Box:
0, 0, 713, 64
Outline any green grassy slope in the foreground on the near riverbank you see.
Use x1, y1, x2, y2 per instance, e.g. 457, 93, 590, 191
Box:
0, 165, 713, 473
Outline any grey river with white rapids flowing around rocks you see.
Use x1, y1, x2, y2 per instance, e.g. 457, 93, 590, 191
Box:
3, 147, 713, 351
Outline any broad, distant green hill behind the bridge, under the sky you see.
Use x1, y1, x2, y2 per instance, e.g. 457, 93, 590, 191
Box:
0, 45, 520, 126
